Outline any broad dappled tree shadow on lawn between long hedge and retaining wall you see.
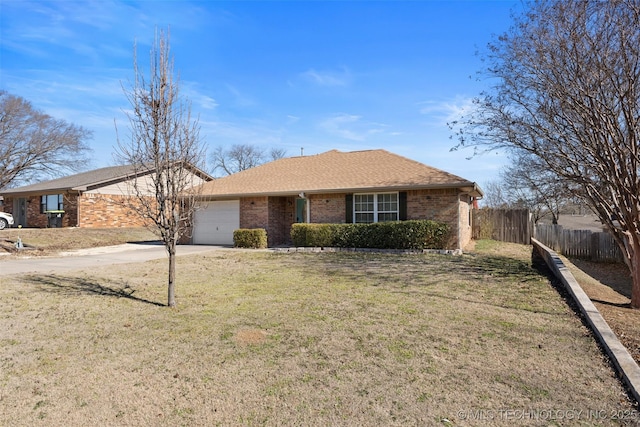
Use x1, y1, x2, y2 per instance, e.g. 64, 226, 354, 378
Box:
280, 252, 562, 315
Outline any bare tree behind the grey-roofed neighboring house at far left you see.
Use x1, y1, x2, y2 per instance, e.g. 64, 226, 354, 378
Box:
0, 90, 91, 189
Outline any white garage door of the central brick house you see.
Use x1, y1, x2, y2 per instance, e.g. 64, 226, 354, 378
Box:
193, 200, 240, 245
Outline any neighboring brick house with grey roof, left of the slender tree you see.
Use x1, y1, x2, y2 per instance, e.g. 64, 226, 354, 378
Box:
0, 165, 213, 228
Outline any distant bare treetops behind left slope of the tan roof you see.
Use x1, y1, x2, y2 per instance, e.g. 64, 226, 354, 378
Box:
211, 144, 286, 175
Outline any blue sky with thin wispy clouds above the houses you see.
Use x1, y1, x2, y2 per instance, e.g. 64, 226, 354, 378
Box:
0, 0, 519, 185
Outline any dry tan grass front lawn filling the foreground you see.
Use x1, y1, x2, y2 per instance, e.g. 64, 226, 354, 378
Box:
0, 242, 640, 426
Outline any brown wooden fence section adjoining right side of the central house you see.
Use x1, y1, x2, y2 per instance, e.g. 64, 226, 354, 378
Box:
473, 208, 533, 245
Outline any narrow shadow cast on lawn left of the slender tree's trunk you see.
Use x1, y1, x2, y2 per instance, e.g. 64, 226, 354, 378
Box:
24, 274, 165, 307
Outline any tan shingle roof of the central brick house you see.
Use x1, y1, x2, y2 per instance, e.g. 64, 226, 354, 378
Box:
202, 150, 476, 197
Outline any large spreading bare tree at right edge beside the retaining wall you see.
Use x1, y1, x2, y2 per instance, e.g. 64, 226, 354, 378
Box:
458, 0, 640, 308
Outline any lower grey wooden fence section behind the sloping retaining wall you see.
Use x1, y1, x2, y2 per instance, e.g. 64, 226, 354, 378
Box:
534, 224, 624, 262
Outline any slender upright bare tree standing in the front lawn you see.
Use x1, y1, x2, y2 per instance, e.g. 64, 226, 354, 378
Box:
117, 31, 205, 307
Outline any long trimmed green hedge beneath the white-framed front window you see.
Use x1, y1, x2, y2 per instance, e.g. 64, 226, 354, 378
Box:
291, 220, 449, 249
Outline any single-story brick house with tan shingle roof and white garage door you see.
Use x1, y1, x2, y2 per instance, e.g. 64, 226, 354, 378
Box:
192, 150, 483, 248
